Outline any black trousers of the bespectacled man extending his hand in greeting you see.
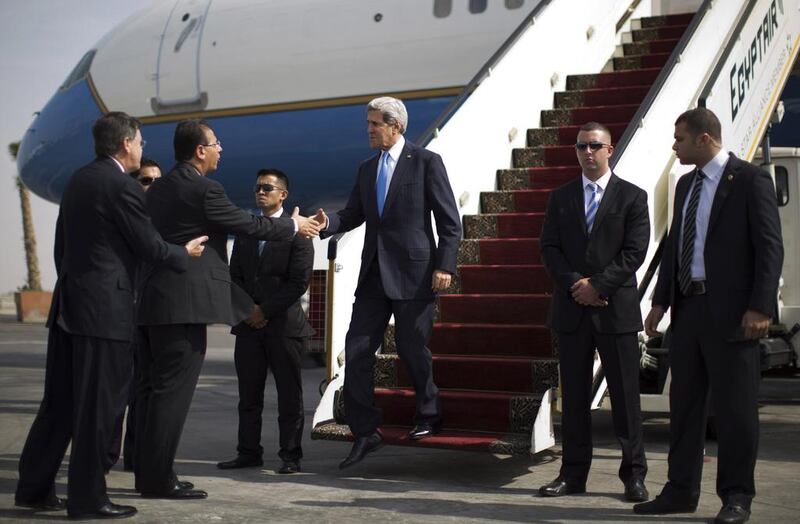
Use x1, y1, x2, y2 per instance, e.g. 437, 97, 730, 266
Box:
133, 324, 206, 494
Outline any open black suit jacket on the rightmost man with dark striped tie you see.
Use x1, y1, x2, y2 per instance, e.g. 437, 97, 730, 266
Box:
653, 154, 783, 338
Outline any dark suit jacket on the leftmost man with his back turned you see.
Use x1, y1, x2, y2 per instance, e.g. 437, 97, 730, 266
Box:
47, 157, 189, 341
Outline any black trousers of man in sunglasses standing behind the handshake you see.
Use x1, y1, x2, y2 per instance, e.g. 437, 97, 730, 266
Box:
233, 329, 305, 461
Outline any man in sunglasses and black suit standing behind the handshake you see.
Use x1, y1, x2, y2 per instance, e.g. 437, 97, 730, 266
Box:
217, 169, 314, 473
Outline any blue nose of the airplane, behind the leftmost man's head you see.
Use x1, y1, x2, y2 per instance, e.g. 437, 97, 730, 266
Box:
17, 79, 102, 203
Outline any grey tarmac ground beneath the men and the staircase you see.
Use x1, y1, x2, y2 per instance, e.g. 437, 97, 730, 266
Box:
0, 317, 800, 523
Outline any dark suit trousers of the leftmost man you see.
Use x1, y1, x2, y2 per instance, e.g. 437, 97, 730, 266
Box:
16, 324, 131, 512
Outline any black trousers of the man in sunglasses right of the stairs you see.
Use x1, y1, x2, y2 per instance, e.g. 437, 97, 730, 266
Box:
558, 312, 647, 483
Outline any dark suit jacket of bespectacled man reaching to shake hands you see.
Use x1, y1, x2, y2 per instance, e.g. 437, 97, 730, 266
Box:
138, 164, 294, 326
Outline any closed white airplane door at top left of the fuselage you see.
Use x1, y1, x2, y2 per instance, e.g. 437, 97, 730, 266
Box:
151, 0, 211, 114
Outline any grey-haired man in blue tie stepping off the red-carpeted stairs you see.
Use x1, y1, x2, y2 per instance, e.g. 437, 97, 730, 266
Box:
320, 97, 461, 468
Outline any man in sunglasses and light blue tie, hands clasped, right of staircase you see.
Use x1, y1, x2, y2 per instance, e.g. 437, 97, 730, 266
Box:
539, 122, 650, 501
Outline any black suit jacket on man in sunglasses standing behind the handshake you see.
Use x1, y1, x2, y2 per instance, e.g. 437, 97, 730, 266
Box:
231, 213, 314, 337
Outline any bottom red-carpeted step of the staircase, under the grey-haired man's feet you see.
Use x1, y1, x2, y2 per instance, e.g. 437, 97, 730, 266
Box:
311, 423, 531, 455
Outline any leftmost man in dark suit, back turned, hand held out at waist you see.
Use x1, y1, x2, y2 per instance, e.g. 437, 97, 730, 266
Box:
15, 113, 206, 518
